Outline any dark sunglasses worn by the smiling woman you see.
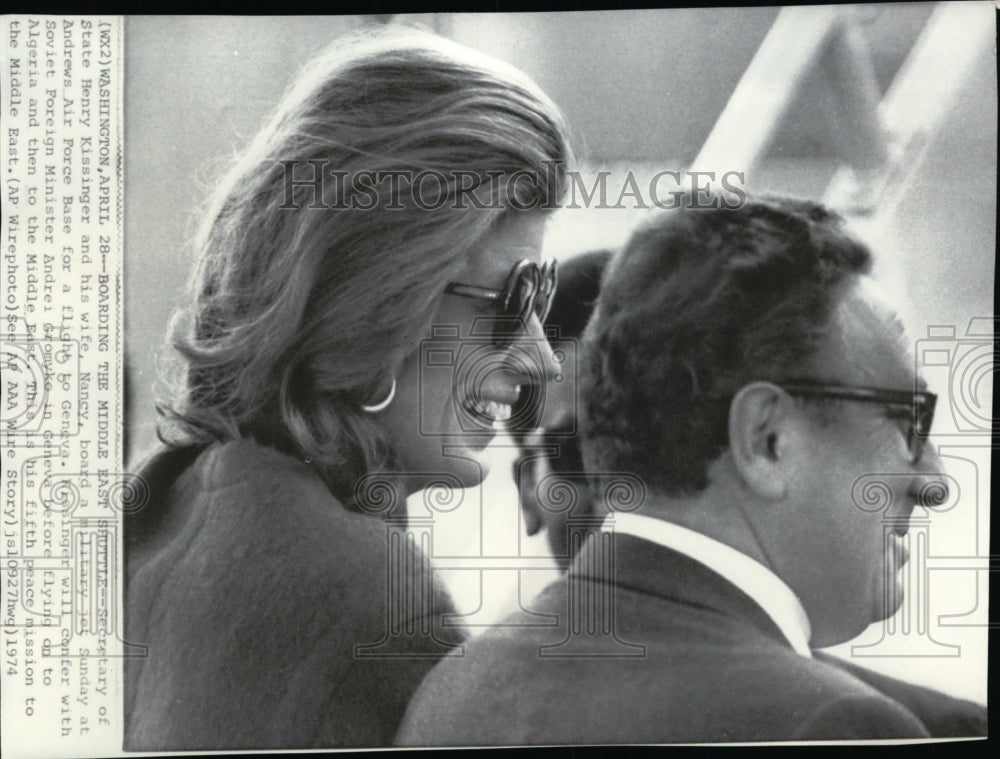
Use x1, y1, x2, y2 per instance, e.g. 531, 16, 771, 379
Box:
445, 259, 556, 347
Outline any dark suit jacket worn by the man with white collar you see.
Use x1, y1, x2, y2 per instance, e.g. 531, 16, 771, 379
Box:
397, 534, 986, 746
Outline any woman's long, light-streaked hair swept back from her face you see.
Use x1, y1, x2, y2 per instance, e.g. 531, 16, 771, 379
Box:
159, 29, 570, 496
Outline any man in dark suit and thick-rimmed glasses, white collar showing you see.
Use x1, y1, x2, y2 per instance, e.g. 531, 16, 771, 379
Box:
398, 200, 986, 745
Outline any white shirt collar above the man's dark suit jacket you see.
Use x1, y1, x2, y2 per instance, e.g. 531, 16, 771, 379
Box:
601, 512, 812, 658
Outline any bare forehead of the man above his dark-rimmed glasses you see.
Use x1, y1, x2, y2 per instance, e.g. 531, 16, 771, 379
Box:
821, 276, 924, 389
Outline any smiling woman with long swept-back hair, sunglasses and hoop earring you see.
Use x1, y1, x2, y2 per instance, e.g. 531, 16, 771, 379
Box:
125, 26, 569, 750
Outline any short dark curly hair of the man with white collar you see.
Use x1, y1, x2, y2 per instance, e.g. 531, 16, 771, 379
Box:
581, 198, 871, 494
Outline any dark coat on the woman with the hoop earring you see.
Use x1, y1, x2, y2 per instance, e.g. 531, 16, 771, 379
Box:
125, 442, 455, 751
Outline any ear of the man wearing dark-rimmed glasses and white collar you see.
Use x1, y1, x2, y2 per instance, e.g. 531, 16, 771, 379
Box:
729, 382, 790, 500
